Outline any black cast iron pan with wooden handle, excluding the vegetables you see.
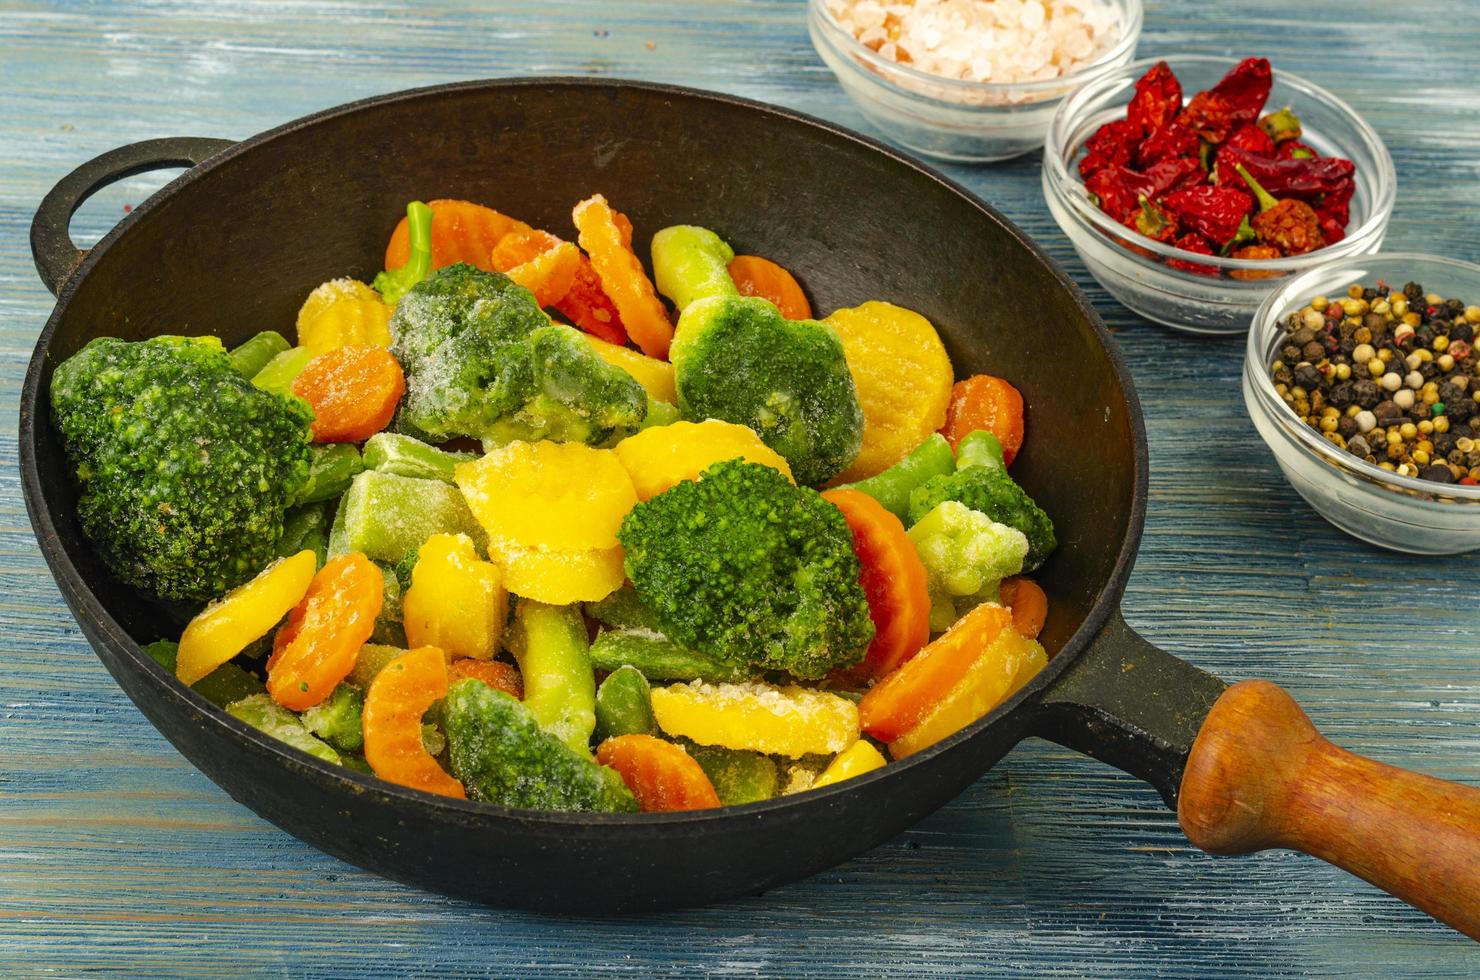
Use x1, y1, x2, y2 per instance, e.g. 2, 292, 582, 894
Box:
21, 78, 1480, 936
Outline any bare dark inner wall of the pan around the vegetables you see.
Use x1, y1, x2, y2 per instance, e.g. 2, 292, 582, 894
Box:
28, 81, 1138, 695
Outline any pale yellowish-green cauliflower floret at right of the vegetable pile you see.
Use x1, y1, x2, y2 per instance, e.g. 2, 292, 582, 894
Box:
909, 500, 1029, 629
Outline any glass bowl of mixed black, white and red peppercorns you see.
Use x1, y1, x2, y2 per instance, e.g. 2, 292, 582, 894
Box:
1243, 253, 1480, 555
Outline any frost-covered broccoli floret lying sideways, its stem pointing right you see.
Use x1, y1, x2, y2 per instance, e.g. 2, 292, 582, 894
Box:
391, 265, 647, 444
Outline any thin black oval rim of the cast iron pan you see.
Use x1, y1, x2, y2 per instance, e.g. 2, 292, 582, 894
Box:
18, 75, 1150, 835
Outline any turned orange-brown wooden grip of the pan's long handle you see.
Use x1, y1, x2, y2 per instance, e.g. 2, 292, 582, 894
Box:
1177, 681, 1480, 940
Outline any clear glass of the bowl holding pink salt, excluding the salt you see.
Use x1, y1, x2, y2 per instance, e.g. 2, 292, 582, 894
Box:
807, 0, 1143, 163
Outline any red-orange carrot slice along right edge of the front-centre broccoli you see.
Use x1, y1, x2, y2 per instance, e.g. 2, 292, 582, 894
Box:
823, 487, 929, 679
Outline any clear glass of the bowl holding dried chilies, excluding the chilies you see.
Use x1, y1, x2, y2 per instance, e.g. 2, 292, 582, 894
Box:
1043, 55, 1397, 335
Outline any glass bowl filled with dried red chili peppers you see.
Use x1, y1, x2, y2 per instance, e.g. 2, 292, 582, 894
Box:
1043, 55, 1397, 335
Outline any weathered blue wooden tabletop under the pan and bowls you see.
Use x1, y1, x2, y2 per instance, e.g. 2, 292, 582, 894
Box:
0, 0, 1480, 977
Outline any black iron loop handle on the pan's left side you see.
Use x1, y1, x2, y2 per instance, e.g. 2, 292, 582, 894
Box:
31, 136, 234, 296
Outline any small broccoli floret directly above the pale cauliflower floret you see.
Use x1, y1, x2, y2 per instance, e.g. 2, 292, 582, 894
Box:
910, 432, 1058, 574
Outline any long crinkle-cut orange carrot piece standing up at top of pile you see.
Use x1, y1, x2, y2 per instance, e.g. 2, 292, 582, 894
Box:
571, 194, 673, 360
